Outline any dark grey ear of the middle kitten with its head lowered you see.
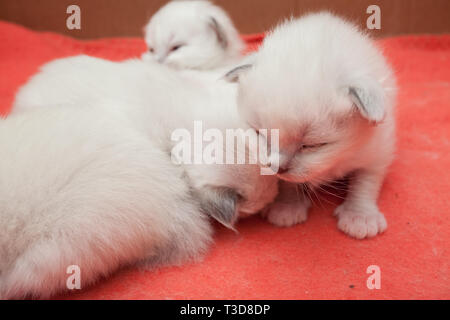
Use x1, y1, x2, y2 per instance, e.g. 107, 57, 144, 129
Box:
199, 186, 241, 231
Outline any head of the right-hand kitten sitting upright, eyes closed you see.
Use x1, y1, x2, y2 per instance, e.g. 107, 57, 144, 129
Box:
227, 13, 392, 183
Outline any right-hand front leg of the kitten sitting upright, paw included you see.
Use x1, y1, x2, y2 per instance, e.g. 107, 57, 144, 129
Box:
334, 170, 387, 239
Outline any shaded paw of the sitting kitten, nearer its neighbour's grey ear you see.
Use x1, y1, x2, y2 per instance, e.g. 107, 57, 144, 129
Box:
263, 199, 311, 227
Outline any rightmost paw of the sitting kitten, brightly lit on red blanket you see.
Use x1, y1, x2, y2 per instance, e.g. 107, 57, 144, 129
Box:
334, 203, 387, 239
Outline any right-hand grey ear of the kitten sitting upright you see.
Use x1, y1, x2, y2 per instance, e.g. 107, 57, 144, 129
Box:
348, 81, 386, 124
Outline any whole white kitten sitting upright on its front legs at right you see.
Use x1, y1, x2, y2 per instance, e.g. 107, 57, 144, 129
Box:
227, 13, 396, 239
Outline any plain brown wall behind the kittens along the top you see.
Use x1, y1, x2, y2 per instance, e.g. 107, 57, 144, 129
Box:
0, 0, 450, 39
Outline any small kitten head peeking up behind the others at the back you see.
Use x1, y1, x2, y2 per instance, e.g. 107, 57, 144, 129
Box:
143, 0, 244, 69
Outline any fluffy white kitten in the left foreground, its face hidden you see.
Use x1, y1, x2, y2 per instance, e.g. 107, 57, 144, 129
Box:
0, 108, 212, 298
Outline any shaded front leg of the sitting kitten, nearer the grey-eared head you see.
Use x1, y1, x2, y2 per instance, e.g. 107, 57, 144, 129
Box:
263, 180, 311, 227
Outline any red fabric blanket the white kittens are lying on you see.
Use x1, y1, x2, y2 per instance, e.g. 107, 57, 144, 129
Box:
0, 22, 450, 299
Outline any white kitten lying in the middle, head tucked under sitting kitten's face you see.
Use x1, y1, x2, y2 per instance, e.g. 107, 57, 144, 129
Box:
12, 56, 276, 212
